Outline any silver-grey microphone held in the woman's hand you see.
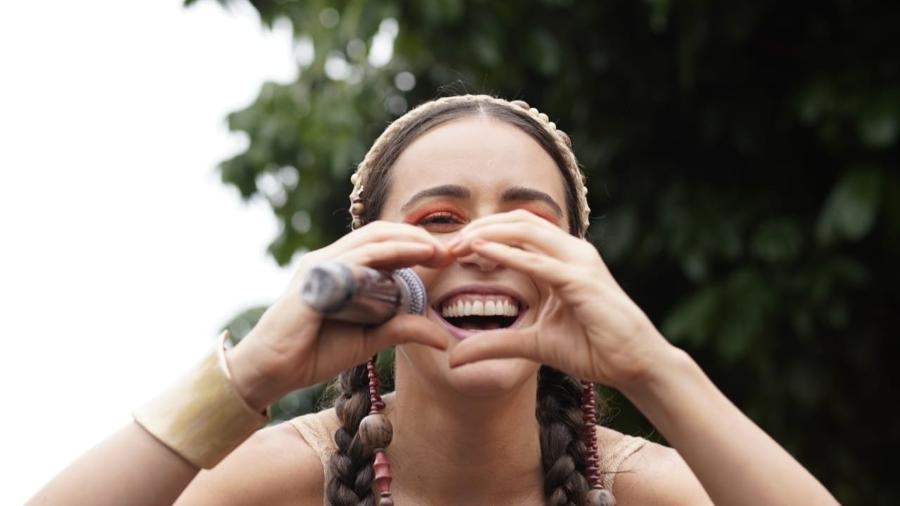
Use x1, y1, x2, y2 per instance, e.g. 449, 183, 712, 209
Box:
300, 262, 427, 325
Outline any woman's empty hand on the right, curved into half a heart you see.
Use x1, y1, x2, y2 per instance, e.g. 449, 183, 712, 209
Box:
449, 210, 673, 388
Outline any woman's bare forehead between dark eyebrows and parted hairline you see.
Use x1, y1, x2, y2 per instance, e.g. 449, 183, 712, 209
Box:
383, 116, 565, 215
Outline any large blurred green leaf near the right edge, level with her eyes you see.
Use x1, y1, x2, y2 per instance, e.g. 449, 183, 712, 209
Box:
816, 167, 884, 245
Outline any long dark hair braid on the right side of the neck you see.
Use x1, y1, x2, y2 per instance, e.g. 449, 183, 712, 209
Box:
536, 366, 590, 506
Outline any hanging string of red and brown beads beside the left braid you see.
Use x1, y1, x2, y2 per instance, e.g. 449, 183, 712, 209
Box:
359, 357, 394, 506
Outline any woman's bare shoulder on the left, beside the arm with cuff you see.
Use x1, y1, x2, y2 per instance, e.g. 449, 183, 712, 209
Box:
176, 422, 325, 505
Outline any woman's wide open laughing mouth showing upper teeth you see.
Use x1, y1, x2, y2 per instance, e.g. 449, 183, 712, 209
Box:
434, 293, 526, 337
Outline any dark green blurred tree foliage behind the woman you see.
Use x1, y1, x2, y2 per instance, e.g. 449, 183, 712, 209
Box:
186, 0, 900, 504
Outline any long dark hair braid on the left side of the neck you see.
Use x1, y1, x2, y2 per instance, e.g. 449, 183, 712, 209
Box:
326, 364, 375, 506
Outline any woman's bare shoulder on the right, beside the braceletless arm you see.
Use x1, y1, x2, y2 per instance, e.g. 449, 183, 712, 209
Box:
598, 428, 712, 506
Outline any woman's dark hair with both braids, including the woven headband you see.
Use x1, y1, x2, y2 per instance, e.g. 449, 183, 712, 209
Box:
326, 95, 615, 506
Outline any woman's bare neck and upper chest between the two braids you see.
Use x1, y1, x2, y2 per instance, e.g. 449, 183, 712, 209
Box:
389, 361, 543, 504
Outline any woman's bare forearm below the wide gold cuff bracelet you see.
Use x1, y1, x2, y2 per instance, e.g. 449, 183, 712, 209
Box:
27, 422, 199, 506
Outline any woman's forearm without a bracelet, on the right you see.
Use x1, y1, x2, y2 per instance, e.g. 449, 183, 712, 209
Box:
622, 348, 837, 505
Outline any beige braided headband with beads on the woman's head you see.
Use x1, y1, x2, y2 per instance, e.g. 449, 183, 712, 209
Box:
350, 95, 591, 237
